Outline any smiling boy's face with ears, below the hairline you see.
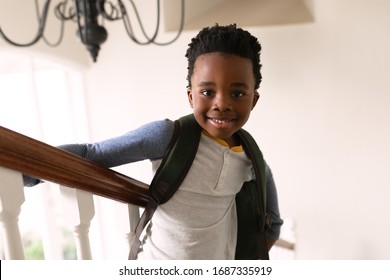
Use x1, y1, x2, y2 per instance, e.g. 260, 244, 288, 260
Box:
188, 53, 259, 146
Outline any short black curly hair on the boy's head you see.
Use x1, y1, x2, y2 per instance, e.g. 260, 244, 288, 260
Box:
185, 24, 262, 90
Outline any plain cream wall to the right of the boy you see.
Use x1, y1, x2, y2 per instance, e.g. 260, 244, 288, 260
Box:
249, 0, 390, 259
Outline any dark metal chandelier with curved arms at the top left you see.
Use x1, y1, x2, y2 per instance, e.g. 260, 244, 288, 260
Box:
0, 0, 184, 62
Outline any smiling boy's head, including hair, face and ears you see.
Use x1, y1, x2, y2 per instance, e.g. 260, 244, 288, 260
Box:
186, 25, 261, 146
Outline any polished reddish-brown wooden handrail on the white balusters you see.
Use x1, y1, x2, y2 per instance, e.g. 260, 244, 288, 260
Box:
0, 126, 149, 207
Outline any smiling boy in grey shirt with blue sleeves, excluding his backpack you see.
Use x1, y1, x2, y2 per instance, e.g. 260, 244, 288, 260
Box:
28, 25, 283, 259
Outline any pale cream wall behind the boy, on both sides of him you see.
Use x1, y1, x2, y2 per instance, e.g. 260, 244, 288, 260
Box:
0, 0, 390, 259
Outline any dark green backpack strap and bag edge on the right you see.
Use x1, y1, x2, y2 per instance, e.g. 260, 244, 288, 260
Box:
235, 129, 271, 260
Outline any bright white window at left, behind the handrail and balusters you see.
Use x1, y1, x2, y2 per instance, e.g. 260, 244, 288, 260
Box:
0, 51, 89, 259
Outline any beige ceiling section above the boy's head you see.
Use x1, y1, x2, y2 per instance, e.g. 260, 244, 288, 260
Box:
164, 0, 314, 31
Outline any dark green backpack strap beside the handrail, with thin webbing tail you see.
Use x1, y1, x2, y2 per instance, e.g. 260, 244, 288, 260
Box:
129, 114, 201, 260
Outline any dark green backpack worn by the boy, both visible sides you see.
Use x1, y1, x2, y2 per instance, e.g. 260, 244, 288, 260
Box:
129, 114, 271, 260
